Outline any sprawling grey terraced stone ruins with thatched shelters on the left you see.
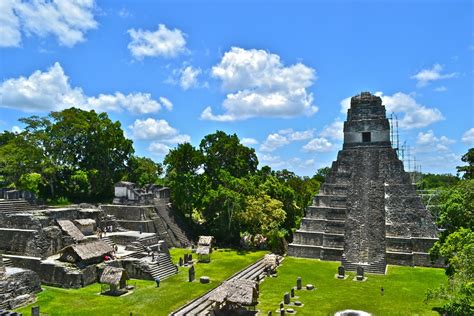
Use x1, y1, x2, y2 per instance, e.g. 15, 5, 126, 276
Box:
0, 181, 191, 298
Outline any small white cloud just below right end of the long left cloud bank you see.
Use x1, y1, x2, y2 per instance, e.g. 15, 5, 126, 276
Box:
129, 118, 178, 139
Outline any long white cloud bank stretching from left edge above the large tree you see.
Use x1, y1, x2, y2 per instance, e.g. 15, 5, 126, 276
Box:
0, 63, 171, 114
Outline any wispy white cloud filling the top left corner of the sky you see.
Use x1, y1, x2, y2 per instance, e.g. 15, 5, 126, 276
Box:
0, 0, 97, 47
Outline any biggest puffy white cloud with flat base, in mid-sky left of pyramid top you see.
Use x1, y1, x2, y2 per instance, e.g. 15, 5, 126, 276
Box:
201, 47, 318, 122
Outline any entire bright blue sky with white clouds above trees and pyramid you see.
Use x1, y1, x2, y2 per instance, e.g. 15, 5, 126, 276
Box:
0, 0, 474, 175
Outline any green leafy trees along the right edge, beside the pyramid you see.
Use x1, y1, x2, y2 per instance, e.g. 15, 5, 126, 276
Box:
426, 148, 474, 315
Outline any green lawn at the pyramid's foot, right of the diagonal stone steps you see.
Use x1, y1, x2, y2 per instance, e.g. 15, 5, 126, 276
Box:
257, 257, 446, 315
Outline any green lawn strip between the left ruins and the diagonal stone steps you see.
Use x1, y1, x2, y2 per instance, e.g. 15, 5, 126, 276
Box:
19, 249, 266, 316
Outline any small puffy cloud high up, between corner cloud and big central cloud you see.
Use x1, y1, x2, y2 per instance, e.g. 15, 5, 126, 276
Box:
127, 24, 186, 59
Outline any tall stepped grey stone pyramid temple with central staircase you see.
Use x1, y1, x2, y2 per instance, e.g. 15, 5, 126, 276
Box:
288, 92, 437, 273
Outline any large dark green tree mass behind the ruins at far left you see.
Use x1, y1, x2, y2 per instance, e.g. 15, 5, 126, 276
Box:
0, 108, 133, 201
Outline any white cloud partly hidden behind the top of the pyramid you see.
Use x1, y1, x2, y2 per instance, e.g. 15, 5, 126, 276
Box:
341, 92, 444, 129
